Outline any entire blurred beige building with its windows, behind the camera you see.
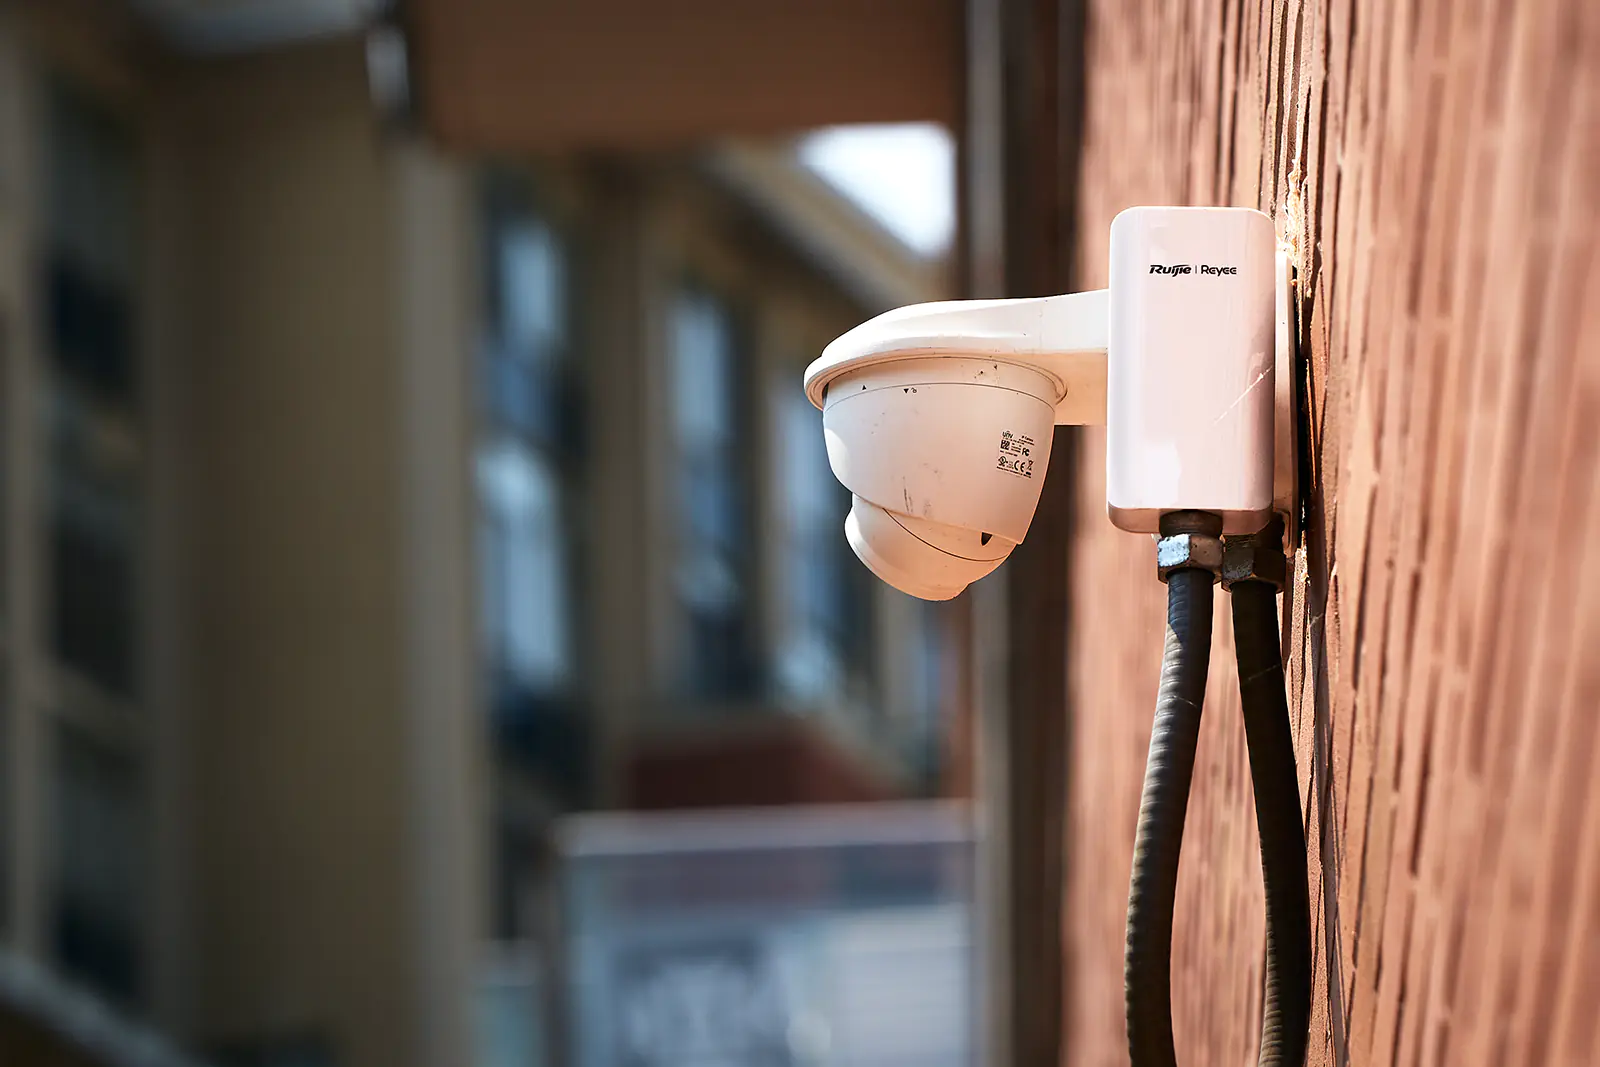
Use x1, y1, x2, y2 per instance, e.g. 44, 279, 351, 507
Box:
0, 3, 966, 1067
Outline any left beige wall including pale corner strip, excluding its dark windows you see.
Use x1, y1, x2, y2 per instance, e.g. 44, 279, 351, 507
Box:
0, 20, 483, 1067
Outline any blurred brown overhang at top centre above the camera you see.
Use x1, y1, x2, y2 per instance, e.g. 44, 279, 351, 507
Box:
403, 0, 963, 154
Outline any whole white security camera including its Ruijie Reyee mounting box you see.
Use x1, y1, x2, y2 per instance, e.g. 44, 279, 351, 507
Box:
805, 208, 1286, 600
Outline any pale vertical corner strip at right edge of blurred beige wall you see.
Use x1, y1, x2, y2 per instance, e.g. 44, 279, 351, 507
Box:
389, 139, 490, 1067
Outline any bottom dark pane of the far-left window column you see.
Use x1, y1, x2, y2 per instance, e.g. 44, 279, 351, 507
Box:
50, 725, 146, 1005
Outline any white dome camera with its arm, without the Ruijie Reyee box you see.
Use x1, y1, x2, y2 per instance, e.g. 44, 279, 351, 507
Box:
805, 290, 1107, 600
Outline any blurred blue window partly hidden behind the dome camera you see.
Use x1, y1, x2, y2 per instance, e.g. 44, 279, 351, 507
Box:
774, 385, 877, 704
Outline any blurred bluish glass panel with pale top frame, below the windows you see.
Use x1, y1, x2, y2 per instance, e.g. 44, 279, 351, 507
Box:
562, 805, 978, 1067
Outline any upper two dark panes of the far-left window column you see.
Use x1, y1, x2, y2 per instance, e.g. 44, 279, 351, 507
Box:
42, 86, 142, 696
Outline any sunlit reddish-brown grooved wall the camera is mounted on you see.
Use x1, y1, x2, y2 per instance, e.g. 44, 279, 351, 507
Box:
1062, 0, 1600, 1067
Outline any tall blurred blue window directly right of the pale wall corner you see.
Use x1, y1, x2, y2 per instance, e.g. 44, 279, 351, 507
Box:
475, 171, 589, 941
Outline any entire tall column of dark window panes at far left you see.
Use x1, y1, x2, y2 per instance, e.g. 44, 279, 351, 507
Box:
37, 85, 149, 1005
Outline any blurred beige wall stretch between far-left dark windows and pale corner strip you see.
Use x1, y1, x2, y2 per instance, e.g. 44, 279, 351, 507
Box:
166, 43, 451, 1067
